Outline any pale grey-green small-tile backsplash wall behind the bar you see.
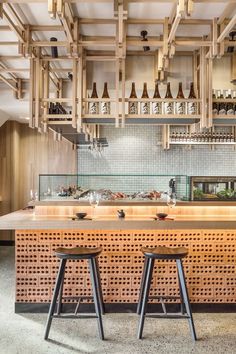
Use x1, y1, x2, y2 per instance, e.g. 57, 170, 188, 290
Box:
78, 126, 236, 194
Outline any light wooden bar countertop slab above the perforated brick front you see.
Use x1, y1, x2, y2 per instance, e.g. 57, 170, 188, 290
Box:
0, 210, 236, 231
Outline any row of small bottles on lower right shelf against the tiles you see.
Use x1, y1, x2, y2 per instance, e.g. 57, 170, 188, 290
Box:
170, 131, 235, 143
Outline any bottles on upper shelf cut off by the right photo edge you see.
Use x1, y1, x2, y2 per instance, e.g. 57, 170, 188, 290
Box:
212, 90, 236, 115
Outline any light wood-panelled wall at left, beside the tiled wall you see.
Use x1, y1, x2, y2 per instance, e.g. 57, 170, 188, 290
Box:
0, 121, 77, 240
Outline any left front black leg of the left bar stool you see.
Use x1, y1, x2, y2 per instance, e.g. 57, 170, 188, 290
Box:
44, 259, 66, 339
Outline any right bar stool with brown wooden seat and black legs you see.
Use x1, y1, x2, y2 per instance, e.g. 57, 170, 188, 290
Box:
137, 246, 197, 340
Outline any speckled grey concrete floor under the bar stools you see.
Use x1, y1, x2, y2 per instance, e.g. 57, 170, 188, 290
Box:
0, 247, 236, 354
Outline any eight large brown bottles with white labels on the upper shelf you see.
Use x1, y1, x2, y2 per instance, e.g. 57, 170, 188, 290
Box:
89, 82, 198, 115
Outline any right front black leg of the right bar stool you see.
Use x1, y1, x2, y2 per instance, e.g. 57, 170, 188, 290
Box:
176, 259, 197, 340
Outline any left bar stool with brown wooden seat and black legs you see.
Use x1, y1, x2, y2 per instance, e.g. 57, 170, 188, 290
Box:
44, 247, 104, 339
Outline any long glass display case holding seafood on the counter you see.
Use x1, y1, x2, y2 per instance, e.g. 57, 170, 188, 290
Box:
39, 174, 189, 201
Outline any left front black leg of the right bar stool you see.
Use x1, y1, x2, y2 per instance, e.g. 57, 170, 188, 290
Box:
138, 258, 154, 339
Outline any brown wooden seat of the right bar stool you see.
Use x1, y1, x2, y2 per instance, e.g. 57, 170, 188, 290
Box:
141, 246, 188, 259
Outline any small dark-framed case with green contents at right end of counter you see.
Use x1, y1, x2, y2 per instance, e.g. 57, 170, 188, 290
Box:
191, 176, 236, 201
